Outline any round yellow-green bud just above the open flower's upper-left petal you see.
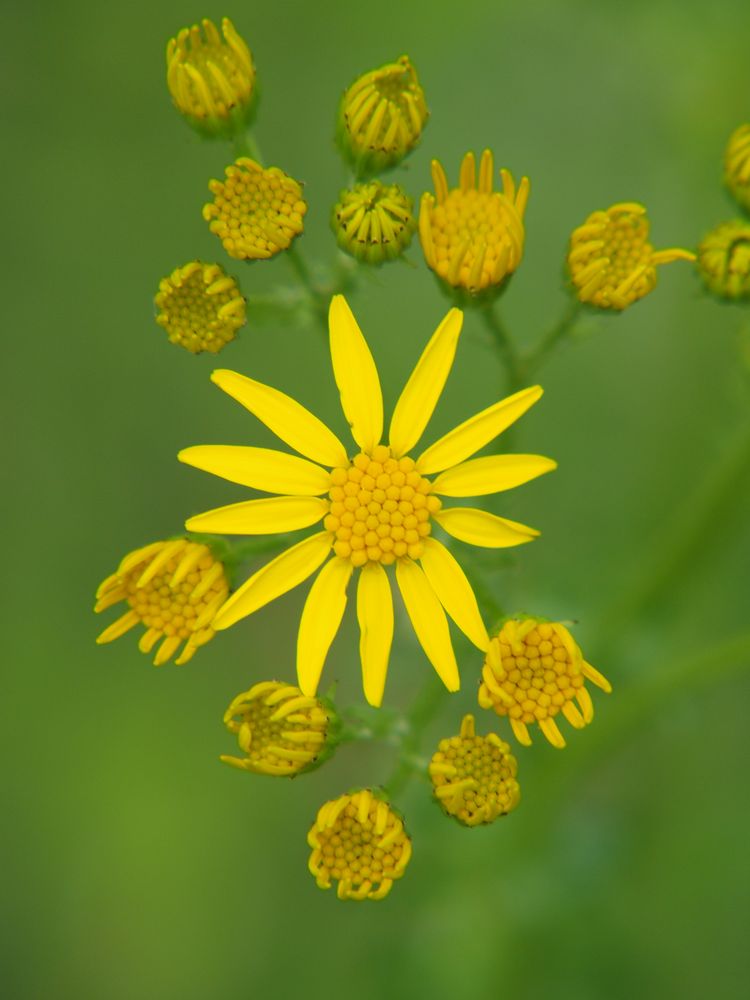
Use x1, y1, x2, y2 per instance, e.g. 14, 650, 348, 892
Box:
154, 260, 246, 354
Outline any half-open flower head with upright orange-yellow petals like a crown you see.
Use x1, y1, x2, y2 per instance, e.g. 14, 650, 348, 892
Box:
419, 149, 529, 295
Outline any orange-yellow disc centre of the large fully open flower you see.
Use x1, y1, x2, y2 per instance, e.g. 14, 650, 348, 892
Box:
324, 445, 440, 566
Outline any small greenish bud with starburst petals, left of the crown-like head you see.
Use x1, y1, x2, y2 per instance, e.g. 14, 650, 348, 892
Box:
331, 181, 416, 264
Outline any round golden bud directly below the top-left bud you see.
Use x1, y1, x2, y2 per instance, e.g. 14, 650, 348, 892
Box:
203, 156, 307, 260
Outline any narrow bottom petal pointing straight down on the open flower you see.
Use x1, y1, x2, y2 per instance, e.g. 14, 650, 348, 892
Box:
357, 562, 393, 708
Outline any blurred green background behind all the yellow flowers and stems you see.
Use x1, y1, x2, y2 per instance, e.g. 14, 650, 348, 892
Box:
5, 0, 750, 1000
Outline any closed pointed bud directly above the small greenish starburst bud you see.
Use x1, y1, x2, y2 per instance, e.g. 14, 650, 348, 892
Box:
338, 56, 429, 176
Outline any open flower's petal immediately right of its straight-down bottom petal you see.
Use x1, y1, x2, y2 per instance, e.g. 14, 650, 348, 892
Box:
396, 559, 460, 691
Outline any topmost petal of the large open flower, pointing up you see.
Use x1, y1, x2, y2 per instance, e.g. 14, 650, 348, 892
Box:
328, 295, 383, 454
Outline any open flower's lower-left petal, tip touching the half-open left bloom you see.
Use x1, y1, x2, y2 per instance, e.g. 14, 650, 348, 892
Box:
211, 531, 331, 629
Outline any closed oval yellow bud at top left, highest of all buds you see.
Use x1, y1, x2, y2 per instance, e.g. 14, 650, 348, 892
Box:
167, 17, 256, 136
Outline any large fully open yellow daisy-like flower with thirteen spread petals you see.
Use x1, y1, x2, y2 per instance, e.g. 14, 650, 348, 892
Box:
179, 295, 555, 705
